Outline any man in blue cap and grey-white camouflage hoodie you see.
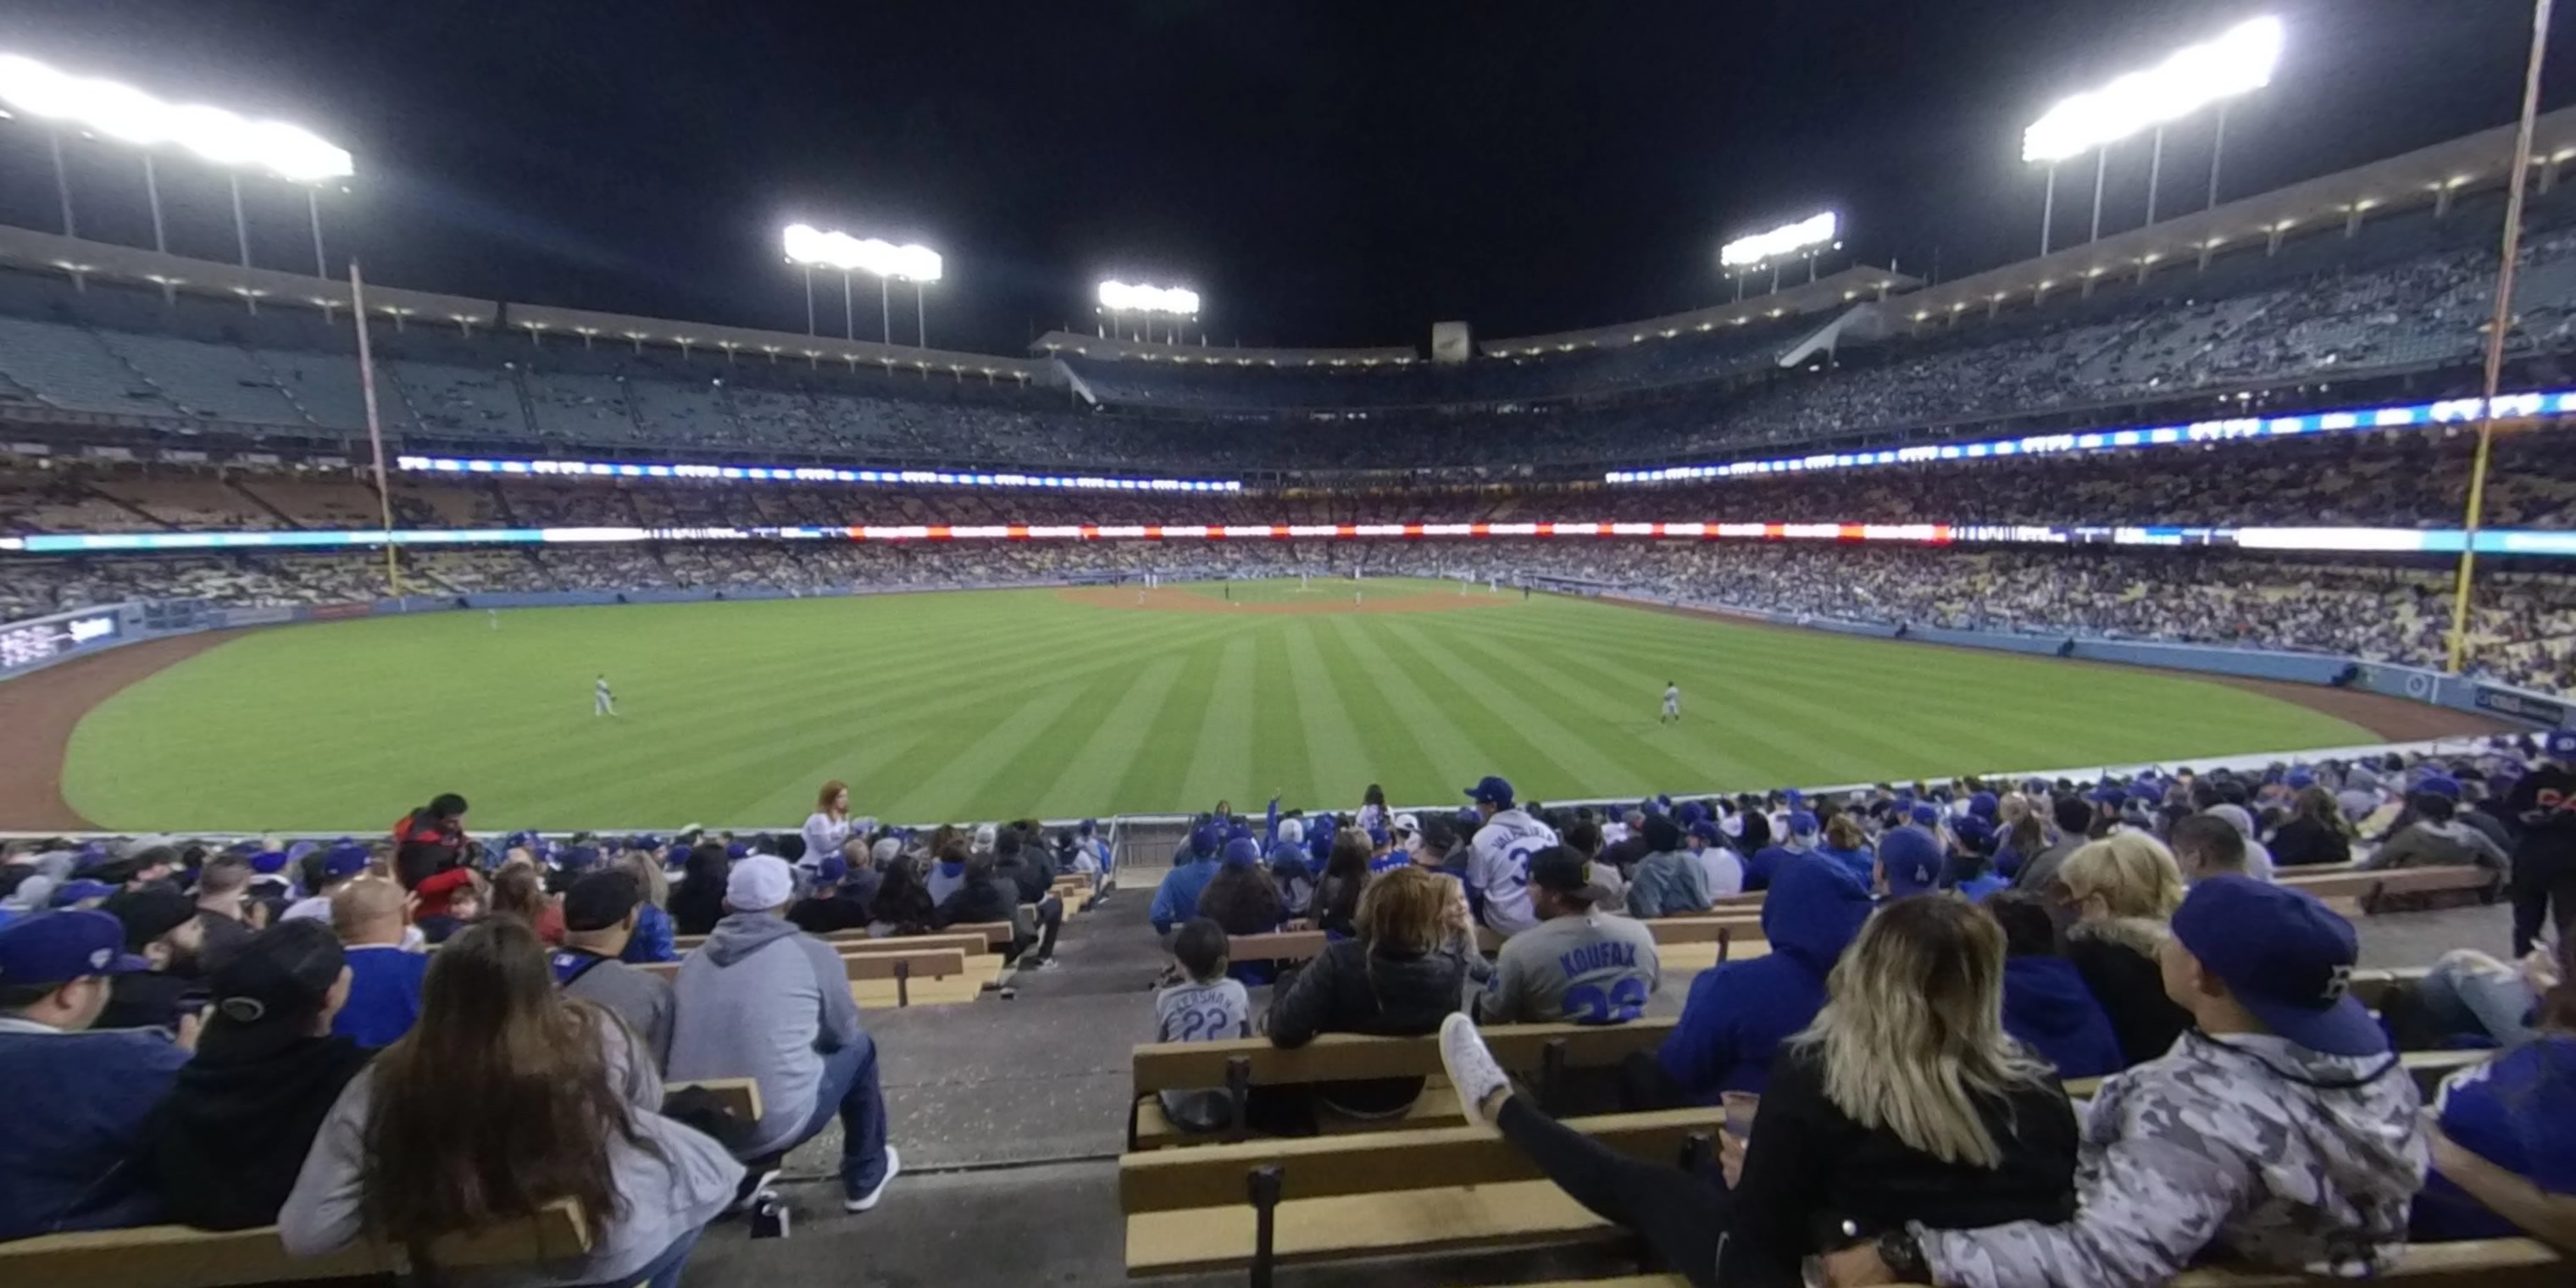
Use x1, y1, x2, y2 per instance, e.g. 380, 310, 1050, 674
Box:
1826, 875, 2427, 1288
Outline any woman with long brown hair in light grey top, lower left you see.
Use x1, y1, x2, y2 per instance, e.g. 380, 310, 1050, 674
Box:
278, 917, 742, 1288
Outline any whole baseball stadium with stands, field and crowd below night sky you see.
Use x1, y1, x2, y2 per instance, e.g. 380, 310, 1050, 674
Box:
0, 7, 2576, 1288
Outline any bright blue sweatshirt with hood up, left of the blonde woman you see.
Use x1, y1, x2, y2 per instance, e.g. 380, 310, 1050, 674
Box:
1659, 855, 1870, 1097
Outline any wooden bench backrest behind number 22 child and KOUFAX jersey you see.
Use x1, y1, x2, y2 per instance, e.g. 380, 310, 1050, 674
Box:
1134, 1015, 1672, 1095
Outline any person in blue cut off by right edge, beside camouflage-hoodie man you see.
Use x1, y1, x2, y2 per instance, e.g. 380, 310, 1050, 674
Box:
2413, 938, 2576, 1246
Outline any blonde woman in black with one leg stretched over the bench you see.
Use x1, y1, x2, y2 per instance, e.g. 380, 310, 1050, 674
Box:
1440, 894, 2079, 1288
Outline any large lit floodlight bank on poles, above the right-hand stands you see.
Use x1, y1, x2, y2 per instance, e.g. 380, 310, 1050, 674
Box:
2022, 18, 2282, 255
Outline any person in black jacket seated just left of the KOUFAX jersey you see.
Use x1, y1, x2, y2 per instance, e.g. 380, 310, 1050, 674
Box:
1265, 865, 1489, 1118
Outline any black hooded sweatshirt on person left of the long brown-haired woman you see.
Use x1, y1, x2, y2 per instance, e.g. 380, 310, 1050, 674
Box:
136, 1020, 371, 1229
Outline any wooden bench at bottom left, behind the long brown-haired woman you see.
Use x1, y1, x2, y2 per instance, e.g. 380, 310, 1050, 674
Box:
0, 1201, 590, 1288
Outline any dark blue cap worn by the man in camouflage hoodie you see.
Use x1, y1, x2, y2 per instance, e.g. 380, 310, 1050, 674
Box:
2174, 874, 2388, 1056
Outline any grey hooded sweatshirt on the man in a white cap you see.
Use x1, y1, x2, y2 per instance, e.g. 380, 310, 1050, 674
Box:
669, 912, 860, 1159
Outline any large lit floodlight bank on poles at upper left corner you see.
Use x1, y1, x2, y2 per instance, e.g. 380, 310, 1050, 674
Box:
0, 54, 356, 278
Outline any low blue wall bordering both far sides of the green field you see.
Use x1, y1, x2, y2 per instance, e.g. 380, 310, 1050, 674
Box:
0, 577, 2576, 729
